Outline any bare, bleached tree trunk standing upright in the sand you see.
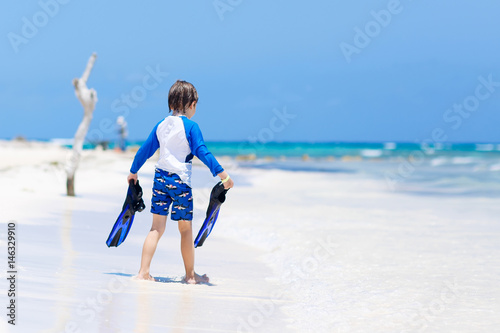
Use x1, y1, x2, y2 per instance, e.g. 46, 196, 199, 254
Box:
66, 53, 97, 196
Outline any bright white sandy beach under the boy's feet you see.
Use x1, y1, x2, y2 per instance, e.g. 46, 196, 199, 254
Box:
0, 142, 500, 333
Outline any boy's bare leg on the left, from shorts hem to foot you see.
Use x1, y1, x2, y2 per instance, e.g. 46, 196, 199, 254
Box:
137, 214, 167, 281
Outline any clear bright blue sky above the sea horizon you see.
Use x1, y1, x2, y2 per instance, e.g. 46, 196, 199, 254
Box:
0, 0, 500, 142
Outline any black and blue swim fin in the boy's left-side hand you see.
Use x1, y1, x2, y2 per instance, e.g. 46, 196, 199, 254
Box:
106, 180, 146, 247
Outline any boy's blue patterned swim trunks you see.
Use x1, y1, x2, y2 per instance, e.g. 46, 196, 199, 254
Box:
151, 169, 193, 221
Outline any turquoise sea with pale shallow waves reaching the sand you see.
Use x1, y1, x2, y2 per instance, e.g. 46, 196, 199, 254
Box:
55, 141, 500, 198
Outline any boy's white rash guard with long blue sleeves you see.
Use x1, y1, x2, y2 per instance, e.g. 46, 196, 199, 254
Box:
130, 116, 224, 187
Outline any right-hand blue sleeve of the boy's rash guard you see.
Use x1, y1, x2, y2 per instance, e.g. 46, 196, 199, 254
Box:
181, 117, 224, 177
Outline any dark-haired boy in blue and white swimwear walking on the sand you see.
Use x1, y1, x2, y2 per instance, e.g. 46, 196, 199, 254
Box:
127, 81, 234, 284
